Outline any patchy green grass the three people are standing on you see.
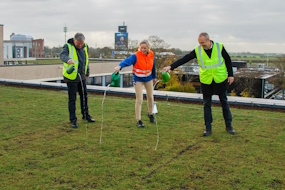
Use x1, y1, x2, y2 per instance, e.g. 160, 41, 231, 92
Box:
0, 85, 285, 190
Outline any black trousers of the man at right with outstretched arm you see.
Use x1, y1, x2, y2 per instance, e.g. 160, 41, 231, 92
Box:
201, 79, 232, 131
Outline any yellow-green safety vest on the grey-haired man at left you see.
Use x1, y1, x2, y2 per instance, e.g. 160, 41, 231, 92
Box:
62, 43, 89, 80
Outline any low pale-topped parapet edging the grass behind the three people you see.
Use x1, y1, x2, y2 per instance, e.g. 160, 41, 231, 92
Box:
0, 77, 285, 112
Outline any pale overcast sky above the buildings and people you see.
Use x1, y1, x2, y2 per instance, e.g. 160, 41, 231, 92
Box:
0, 0, 285, 53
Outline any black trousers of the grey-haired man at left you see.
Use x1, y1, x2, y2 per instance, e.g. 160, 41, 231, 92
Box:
67, 80, 89, 121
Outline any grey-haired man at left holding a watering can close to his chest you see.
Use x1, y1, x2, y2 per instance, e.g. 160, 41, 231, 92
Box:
60, 33, 95, 128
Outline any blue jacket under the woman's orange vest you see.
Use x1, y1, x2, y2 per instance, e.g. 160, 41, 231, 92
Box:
119, 54, 156, 82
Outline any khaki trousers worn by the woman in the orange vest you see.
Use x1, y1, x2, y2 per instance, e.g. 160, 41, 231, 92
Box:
134, 80, 153, 121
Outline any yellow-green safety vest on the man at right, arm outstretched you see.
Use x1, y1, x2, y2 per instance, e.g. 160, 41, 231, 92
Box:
195, 42, 228, 84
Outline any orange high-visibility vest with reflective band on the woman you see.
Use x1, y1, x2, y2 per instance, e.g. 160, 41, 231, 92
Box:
133, 50, 154, 77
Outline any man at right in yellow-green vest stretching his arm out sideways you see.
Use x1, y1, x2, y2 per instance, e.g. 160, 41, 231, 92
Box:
163, 32, 235, 136
